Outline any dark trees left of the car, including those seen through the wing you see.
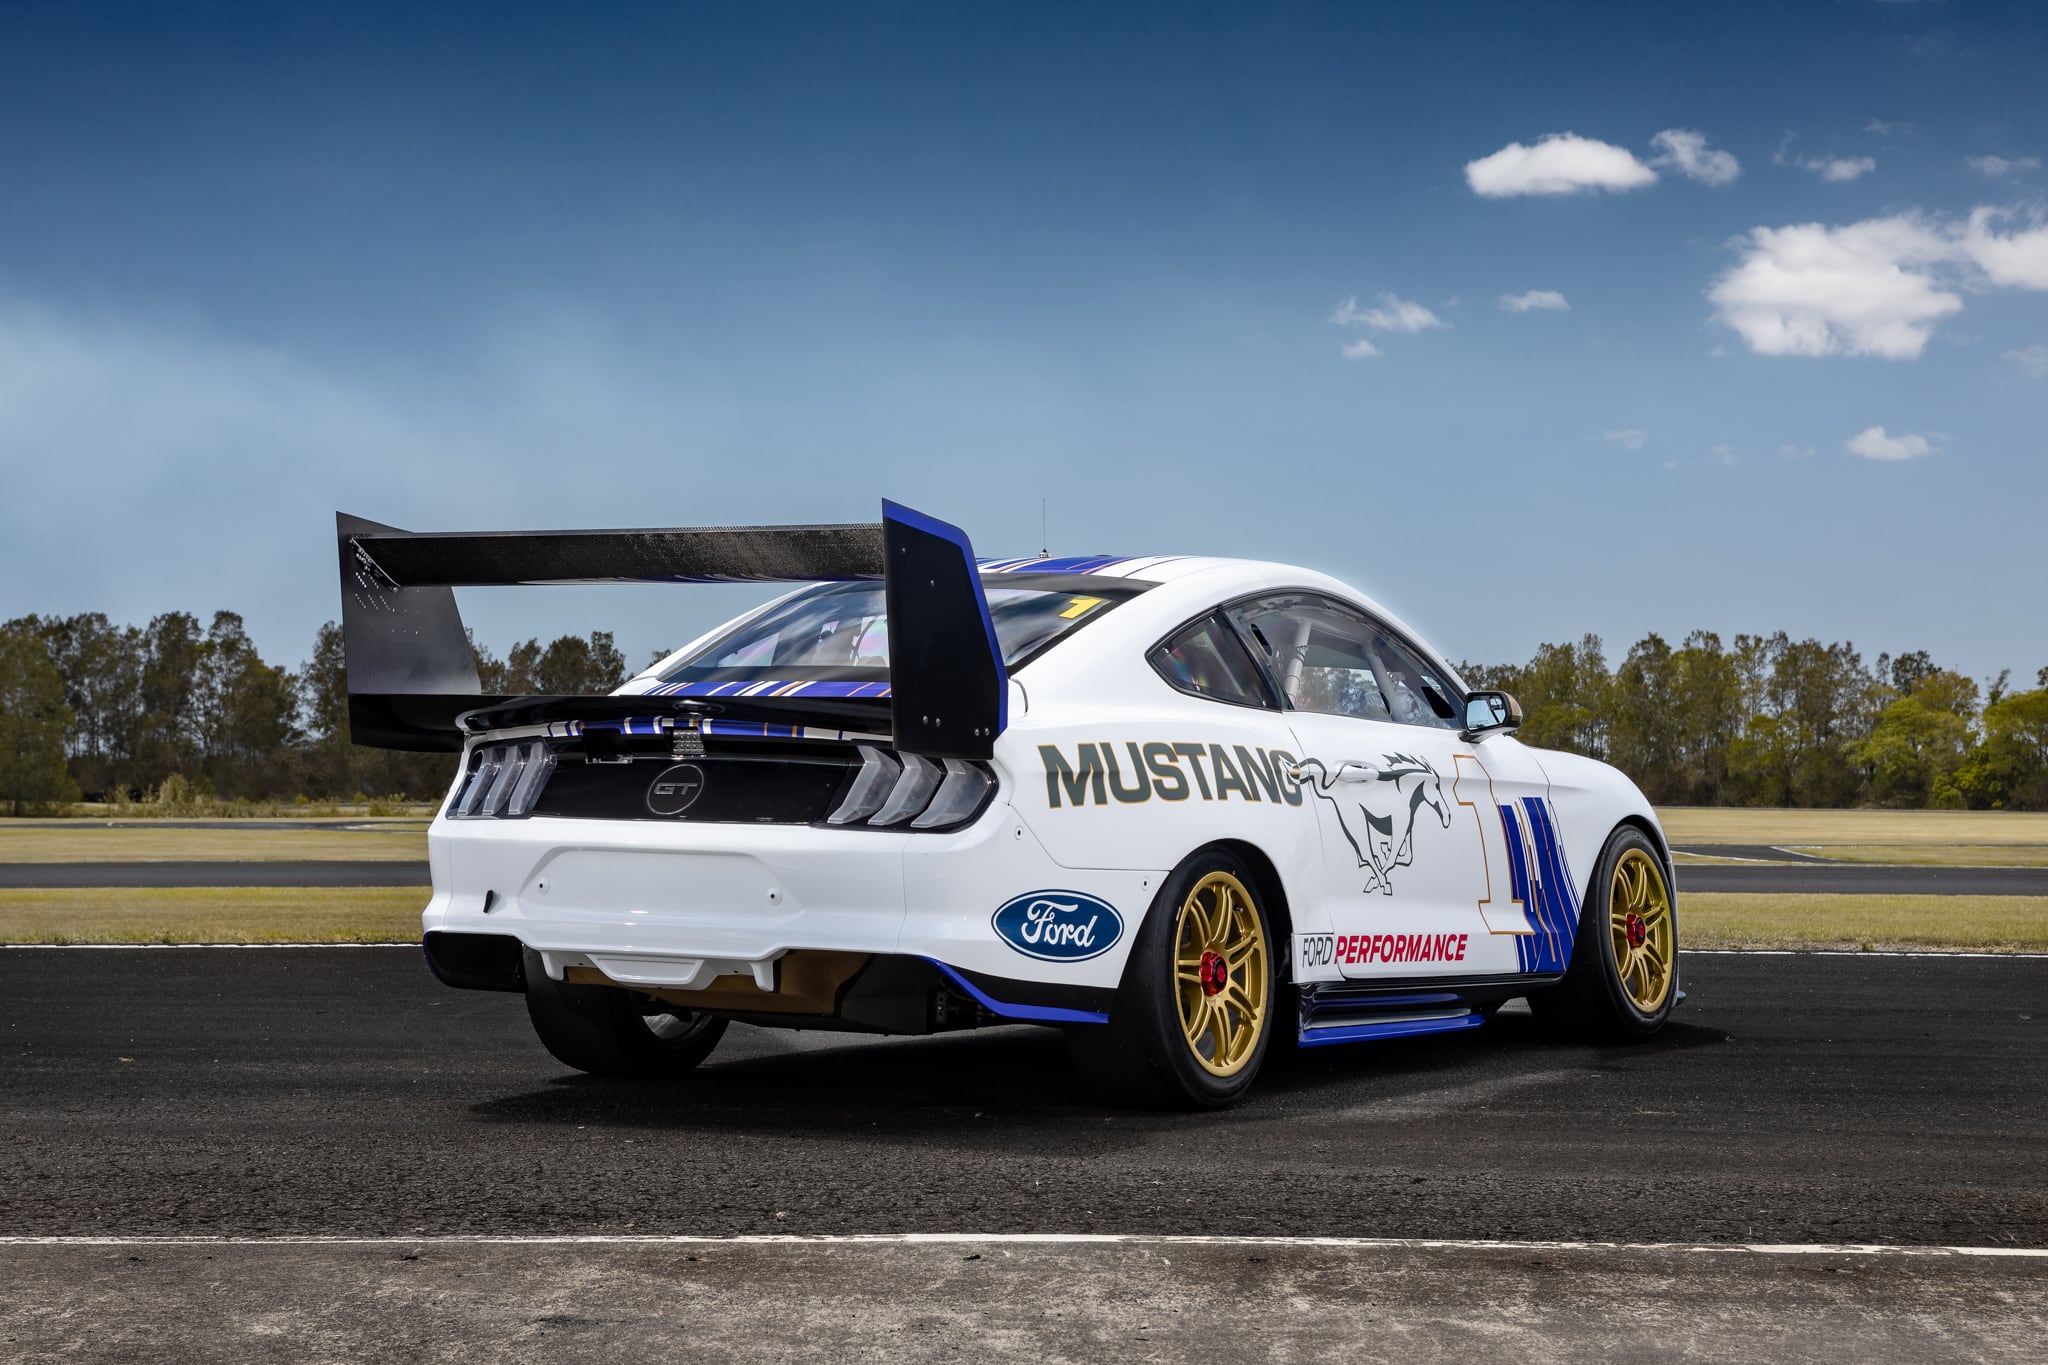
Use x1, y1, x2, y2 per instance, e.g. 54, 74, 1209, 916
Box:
0, 612, 627, 814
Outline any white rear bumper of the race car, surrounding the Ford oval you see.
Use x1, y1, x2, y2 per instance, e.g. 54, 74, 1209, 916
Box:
422, 804, 1163, 1001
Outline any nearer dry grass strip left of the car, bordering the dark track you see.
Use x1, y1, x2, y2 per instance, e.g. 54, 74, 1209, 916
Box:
0, 886, 428, 943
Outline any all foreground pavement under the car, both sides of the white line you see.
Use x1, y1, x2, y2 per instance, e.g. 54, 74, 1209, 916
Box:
0, 948, 2048, 1363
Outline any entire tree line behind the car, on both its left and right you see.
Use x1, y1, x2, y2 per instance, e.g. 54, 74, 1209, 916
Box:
0, 612, 2048, 814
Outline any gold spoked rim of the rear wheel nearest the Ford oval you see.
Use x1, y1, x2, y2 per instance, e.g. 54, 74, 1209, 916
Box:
1174, 872, 1272, 1076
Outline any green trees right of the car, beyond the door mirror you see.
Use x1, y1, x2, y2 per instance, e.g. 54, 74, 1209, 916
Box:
1460, 630, 2048, 810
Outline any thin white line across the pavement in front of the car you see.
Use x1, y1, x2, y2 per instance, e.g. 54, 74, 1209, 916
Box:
0, 1232, 2048, 1261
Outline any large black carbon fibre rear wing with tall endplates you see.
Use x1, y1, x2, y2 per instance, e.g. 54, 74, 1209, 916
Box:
334, 501, 1010, 759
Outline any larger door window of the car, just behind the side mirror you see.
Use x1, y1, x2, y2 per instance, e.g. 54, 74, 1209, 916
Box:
1229, 593, 1458, 729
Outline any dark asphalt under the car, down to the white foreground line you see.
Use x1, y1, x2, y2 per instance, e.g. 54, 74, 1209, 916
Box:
0, 948, 2048, 1246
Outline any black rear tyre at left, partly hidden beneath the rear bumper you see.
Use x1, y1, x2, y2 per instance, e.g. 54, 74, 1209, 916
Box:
526, 948, 725, 1076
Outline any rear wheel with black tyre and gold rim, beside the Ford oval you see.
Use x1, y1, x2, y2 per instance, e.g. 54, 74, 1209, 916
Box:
1067, 849, 1282, 1109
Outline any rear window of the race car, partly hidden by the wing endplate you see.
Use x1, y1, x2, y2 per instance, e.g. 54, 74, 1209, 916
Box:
662, 575, 1149, 684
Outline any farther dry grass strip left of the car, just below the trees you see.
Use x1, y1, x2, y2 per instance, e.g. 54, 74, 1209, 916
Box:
0, 821, 426, 864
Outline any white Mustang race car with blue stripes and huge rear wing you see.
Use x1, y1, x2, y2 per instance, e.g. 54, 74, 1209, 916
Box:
338, 503, 1679, 1107
